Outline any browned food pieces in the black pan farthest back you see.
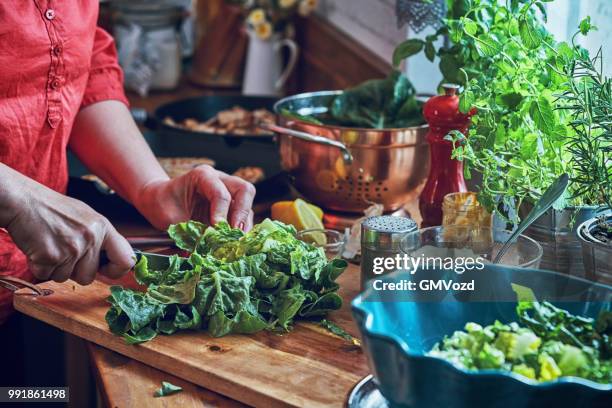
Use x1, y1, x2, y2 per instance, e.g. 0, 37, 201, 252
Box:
164, 106, 276, 135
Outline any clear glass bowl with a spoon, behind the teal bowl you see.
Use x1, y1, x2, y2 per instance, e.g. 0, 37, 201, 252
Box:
401, 225, 543, 269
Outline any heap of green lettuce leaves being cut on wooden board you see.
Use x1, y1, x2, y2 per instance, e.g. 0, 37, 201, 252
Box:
106, 219, 347, 344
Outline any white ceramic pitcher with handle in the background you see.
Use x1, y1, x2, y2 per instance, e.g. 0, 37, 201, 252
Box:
242, 33, 298, 95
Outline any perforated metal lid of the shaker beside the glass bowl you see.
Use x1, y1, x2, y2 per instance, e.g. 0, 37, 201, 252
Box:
361, 215, 417, 249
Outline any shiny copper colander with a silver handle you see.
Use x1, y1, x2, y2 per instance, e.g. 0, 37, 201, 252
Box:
271, 91, 429, 212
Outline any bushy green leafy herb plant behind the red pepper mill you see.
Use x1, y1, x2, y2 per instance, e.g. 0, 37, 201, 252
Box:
393, 0, 609, 220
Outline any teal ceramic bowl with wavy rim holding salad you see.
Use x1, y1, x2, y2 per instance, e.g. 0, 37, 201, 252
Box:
352, 265, 612, 408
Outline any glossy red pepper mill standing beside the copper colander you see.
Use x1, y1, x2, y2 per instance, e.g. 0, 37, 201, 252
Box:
419, 84, 476, 227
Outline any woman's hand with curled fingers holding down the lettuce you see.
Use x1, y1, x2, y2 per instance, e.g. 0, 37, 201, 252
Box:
134, 165, 255, 231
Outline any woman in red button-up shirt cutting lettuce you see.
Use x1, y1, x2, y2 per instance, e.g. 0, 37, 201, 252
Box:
0, 0, 255, 324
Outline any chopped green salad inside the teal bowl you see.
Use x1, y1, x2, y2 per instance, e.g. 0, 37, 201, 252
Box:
429, 301, 612, 384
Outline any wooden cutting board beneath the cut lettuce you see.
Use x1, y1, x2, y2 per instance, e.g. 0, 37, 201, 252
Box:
14, 265, 368, 408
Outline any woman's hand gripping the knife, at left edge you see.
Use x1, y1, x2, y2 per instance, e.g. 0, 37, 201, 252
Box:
0, 164, 135, 285
